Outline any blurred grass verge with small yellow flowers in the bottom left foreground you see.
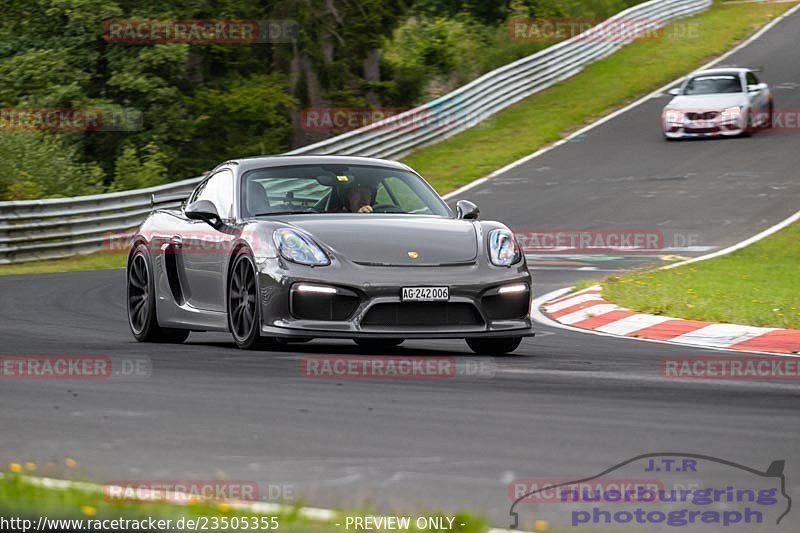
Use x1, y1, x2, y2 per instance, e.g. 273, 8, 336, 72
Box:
0, 473, 488, 533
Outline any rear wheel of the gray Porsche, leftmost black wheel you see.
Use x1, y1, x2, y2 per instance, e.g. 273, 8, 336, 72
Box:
126, 243, 189, 344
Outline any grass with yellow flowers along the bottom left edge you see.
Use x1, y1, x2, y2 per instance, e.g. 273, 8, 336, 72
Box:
0, 473, 488, 533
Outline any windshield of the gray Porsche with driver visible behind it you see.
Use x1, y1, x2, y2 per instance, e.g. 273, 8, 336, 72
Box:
241, 164, 450, 217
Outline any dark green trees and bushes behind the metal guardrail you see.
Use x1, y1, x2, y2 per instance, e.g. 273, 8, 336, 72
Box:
0, 0, 648, 200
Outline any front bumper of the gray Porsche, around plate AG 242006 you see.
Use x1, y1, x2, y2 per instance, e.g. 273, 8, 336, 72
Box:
258, 259, 534, 339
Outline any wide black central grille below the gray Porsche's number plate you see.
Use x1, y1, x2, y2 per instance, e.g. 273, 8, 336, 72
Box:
361, 302, 483, 327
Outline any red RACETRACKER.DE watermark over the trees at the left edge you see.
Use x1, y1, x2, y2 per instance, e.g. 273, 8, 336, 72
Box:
0, 107, 144, 132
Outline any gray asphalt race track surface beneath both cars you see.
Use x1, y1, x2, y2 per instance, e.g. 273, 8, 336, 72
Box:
0, 7, 800, 531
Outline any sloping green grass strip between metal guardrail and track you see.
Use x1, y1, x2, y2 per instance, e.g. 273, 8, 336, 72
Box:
404, 2, 794, 193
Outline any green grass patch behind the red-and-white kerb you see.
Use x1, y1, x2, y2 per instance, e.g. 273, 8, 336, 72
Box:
602, 223, 800, 329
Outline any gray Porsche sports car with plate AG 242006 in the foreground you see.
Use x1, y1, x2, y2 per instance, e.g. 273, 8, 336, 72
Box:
127, 156, 533, 354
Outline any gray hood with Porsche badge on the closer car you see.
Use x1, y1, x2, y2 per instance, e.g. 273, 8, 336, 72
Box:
286, 214, 478, 266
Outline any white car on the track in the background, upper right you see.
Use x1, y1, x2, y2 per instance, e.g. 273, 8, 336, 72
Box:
661, 68, 774, 140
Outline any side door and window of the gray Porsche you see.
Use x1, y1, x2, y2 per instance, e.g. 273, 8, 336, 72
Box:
183, 169, 235, 312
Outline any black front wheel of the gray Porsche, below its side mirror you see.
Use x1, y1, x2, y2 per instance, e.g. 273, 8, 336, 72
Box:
228, 249, 275, 350
